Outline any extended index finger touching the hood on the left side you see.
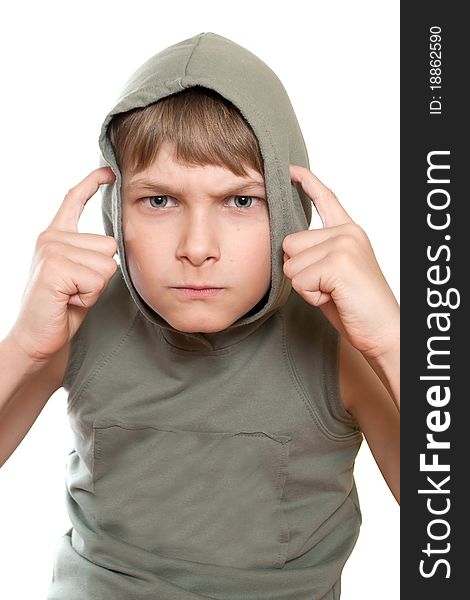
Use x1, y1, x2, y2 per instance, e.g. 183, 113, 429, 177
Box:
47, 167, 116, 231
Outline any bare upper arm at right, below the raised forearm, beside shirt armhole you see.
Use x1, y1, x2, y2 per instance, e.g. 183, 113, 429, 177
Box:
339, 336, 400, 503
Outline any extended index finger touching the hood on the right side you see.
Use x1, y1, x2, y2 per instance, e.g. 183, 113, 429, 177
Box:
289, 165, 353, 227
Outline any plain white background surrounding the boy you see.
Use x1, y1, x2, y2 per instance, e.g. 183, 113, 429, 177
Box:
0, 0, 400, 600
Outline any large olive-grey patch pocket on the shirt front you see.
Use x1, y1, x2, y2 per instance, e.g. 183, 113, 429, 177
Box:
93, 425, 292, 568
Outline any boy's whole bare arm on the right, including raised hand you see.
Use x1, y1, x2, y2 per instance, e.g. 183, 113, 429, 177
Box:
283, 165, 400, 501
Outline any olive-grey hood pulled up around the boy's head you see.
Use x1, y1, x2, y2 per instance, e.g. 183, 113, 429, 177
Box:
99, 32, 312, 350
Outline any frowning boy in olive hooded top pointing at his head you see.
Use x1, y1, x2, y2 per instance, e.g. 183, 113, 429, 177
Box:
0, 33, 399, 600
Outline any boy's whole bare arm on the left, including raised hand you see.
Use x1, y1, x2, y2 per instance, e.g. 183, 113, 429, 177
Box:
0, 167, 117, 466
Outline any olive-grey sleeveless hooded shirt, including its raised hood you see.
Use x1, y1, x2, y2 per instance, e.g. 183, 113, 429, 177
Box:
47, 33, 362, 600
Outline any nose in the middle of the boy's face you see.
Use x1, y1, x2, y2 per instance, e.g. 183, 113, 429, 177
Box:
176, 211, 220, 266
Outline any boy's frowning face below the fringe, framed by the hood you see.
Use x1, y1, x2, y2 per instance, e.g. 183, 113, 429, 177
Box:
122, 142, 271, 333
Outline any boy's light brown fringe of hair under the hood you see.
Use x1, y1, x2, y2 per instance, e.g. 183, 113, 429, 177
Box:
108, 86, 264, 177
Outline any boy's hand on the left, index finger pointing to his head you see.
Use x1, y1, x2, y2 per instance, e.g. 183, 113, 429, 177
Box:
9, 167, 117, 362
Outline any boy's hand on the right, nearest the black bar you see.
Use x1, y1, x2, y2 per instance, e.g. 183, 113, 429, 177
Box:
282, 165, 400, 360
